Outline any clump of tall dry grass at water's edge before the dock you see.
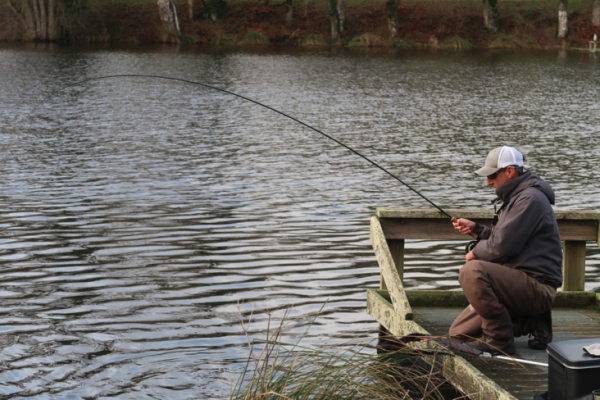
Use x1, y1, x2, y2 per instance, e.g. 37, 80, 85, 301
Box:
230, 304, 461, 400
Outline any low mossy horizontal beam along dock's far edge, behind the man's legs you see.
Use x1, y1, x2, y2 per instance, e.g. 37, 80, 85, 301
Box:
376, 290, 600, 308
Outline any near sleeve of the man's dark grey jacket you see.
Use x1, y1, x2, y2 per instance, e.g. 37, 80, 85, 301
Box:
473, 196, 543, 264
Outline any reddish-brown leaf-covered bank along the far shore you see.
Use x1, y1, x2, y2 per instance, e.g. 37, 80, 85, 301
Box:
0, 1, 600, 49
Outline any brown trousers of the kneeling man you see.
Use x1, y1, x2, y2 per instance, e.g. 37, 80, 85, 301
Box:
450, 260, 556, 341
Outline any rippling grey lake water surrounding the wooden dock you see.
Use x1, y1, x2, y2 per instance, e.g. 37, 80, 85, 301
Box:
0, 45, 600, 399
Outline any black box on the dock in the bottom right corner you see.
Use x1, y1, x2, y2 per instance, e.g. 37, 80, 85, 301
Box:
546, 338, 600, 400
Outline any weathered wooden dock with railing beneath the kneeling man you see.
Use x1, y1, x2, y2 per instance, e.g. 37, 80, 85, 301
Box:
367, 209, 600, 400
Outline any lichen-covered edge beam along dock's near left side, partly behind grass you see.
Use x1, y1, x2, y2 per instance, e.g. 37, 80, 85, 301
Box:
367, 290, 516, 400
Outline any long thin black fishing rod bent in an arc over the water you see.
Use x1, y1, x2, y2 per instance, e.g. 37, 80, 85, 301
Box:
28, 74, 455, 221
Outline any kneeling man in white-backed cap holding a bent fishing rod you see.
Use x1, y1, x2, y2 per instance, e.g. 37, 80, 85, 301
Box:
450, 146, 562, 354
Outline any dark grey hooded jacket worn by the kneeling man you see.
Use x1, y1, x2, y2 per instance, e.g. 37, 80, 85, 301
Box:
473, 171, 562, 288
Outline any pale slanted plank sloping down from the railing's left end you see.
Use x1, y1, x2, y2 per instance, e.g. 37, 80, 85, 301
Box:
371, 217, 413, 320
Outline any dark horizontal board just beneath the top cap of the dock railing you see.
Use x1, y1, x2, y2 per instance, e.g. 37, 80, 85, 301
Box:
380, 218, 599, 241
